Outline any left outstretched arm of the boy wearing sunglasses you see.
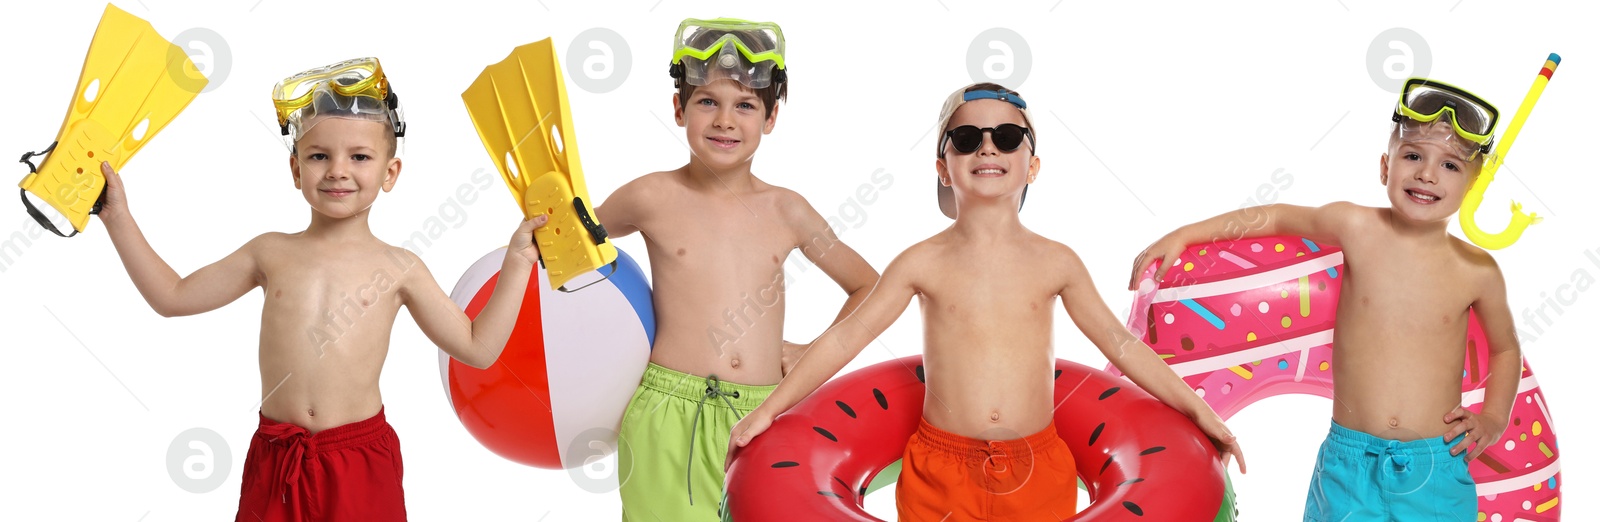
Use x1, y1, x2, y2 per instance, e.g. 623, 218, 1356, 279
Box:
728, 247, 920, 453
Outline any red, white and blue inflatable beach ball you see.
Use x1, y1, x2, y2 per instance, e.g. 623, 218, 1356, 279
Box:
438, 248, 656, 469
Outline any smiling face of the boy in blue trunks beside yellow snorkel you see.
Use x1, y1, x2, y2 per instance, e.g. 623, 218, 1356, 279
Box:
1379, 123, 1485, 223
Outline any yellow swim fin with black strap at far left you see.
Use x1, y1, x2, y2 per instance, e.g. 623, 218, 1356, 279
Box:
18, 3, 206, 237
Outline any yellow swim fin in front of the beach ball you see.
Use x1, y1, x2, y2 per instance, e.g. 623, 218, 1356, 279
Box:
461, 38, 616, 291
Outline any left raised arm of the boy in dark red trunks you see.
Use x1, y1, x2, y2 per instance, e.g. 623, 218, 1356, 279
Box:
99, 162, 261, 317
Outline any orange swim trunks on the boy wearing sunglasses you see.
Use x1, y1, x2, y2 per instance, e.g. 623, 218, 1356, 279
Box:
894, 420, 1078, 522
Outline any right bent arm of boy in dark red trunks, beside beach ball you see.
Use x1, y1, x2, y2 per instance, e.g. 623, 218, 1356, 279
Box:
400, 215, 549, 368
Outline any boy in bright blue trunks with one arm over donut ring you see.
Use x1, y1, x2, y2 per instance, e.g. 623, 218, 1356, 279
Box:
1128, 78, 1522, 522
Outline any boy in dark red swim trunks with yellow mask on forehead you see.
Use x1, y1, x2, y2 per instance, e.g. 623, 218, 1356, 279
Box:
99, 58, 546, 520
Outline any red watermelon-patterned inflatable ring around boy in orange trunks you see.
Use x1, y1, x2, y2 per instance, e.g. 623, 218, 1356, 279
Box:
722, 355, 1232, 522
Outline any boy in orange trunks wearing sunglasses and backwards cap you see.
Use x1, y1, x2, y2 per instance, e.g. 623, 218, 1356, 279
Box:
730, 83, 1243, 520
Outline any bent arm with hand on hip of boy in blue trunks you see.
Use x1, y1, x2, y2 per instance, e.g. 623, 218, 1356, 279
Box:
1445, 255, 1522, 463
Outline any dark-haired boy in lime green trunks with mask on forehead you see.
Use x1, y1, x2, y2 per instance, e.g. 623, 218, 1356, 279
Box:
595, 19, 878, 522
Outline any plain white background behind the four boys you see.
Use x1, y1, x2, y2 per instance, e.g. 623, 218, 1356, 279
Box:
0, 0, 1600, 520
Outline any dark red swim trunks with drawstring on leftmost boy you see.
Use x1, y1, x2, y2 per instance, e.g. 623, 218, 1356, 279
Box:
234, 408, 405, 522
